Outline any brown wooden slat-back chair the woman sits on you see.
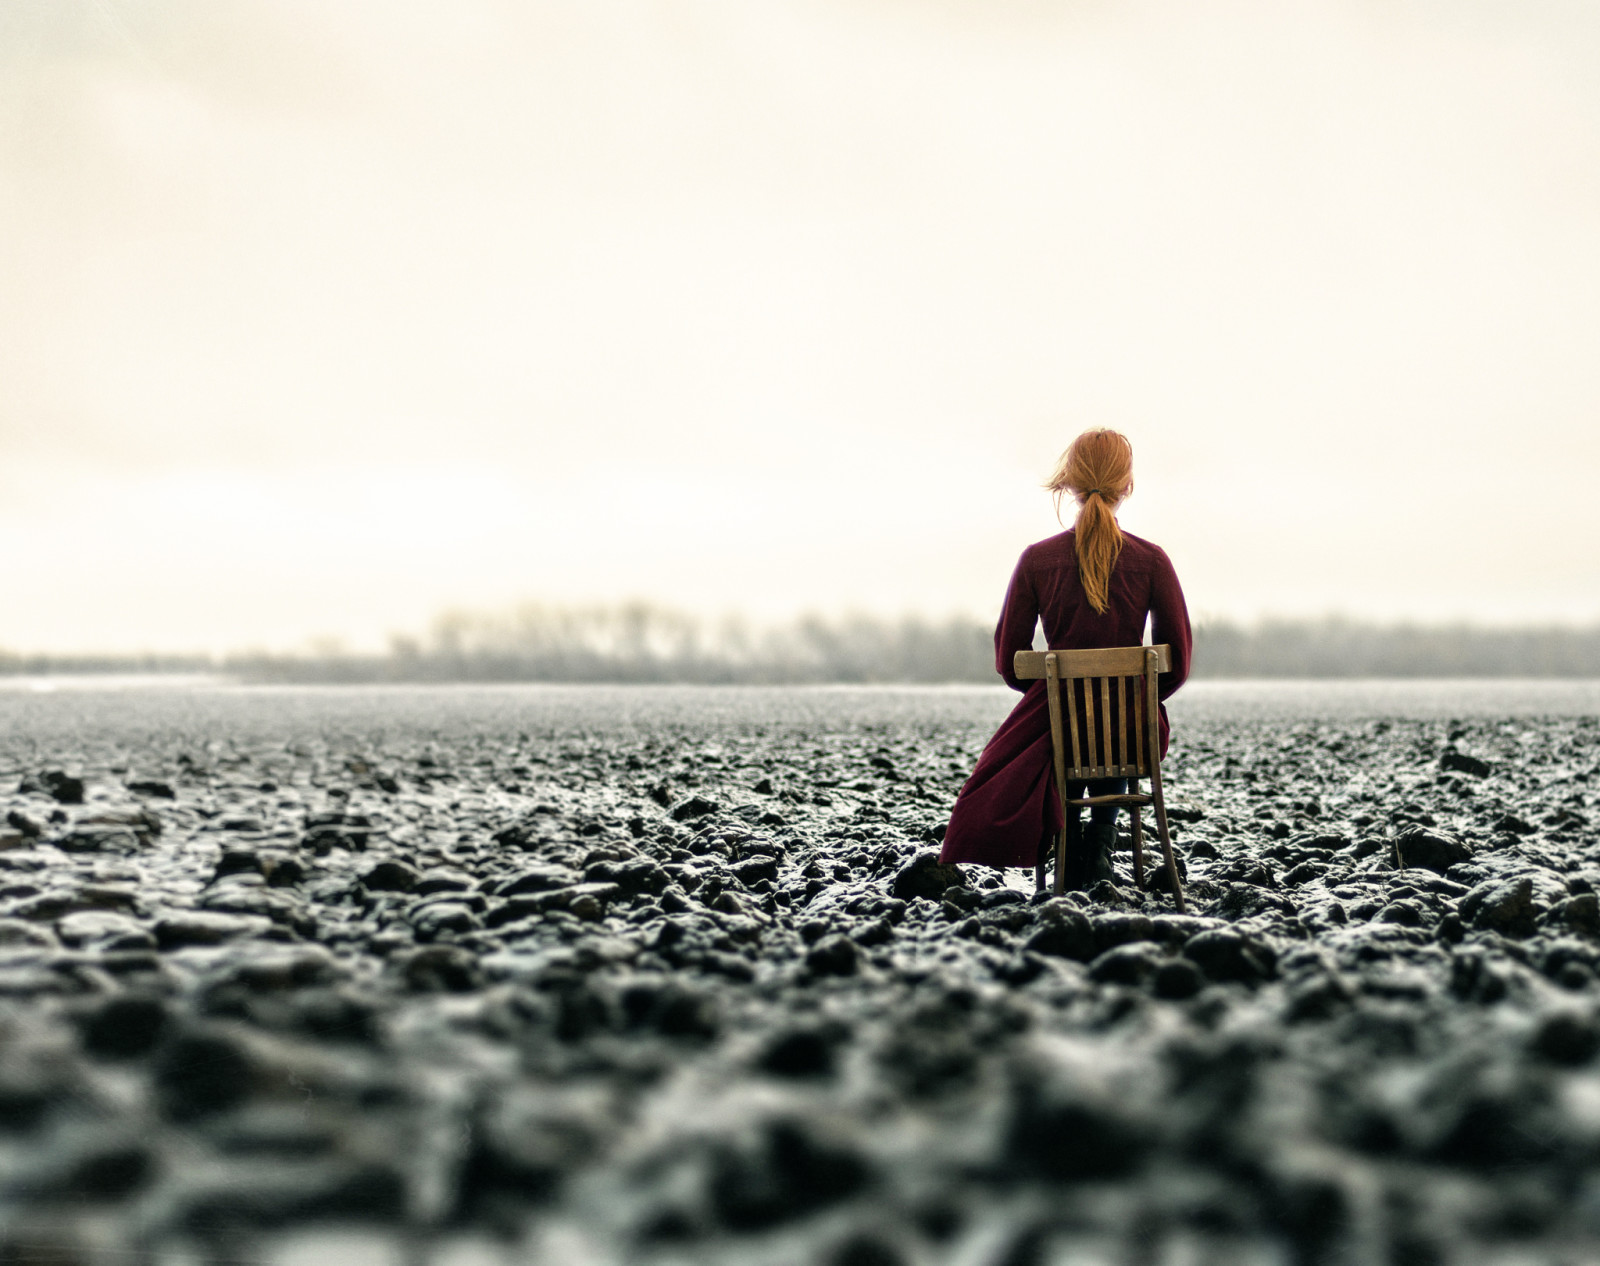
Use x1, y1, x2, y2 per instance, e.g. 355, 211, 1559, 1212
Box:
1014, 645, 1189, 914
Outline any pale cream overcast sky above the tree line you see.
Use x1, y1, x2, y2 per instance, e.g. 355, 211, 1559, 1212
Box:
0, 0, 1600, 651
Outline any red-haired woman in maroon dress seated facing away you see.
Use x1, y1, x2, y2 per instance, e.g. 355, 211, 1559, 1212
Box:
939, 431, 1190, 888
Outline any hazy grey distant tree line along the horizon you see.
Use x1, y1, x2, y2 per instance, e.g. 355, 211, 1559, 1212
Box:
0, 603, 1600, 685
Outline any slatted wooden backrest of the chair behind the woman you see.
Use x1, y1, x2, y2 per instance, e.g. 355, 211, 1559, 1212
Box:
1014, 643, 1171, 783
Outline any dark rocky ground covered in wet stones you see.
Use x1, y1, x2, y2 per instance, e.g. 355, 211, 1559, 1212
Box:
0, 695, 1600, 1266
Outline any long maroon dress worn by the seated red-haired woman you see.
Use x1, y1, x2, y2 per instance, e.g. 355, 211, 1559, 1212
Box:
939, 530, 1190, 866
